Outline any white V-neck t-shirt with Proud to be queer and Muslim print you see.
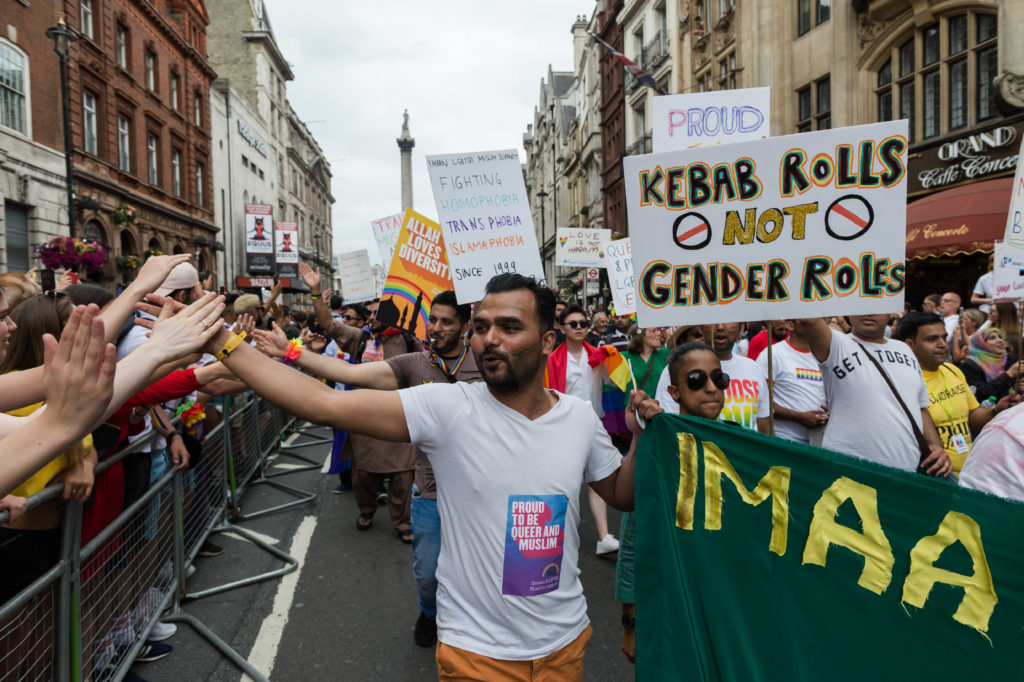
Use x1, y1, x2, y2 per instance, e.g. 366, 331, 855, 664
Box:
398, 383, 622, 660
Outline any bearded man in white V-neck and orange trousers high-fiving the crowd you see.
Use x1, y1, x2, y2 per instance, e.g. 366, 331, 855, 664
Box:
181, 272, 656, 680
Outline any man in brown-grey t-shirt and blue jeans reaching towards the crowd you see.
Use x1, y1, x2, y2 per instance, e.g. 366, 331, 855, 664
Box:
254, 291, 481, 646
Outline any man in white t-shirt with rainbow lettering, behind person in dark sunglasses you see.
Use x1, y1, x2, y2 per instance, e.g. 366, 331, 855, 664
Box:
654, 323, 768, 433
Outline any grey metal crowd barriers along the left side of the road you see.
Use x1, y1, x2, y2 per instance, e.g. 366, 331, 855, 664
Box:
0, 396, 315, 682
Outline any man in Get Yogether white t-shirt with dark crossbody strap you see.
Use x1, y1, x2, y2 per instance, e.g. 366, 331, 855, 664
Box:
800, 314, 952, 476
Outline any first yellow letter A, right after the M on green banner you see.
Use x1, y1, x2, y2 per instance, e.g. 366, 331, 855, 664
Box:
803, 476, 895, 594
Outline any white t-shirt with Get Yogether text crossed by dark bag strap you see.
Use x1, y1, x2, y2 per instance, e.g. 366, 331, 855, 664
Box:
821, 332, 931, 471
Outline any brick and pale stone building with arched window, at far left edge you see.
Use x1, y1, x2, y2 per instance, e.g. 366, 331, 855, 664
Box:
0, 0, 71, 271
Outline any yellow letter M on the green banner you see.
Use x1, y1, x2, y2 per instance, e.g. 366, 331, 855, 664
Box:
702, 441, 790, 556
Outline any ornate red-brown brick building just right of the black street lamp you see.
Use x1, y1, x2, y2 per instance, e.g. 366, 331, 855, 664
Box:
63, 0, 217, 281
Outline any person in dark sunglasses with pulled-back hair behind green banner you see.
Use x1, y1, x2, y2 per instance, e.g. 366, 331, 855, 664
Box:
615, 341, 729, 663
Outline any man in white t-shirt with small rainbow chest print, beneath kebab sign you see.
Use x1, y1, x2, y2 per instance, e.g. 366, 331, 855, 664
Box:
758, 319, 828, 445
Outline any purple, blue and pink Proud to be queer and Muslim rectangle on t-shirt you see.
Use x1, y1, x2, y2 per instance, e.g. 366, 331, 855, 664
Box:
502, 495, 568, 597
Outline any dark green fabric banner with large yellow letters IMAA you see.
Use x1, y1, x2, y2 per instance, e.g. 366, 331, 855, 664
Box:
636, 415, 1024, 682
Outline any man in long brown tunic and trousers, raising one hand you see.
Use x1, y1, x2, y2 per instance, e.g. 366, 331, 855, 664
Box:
299, 263, 423, 545
